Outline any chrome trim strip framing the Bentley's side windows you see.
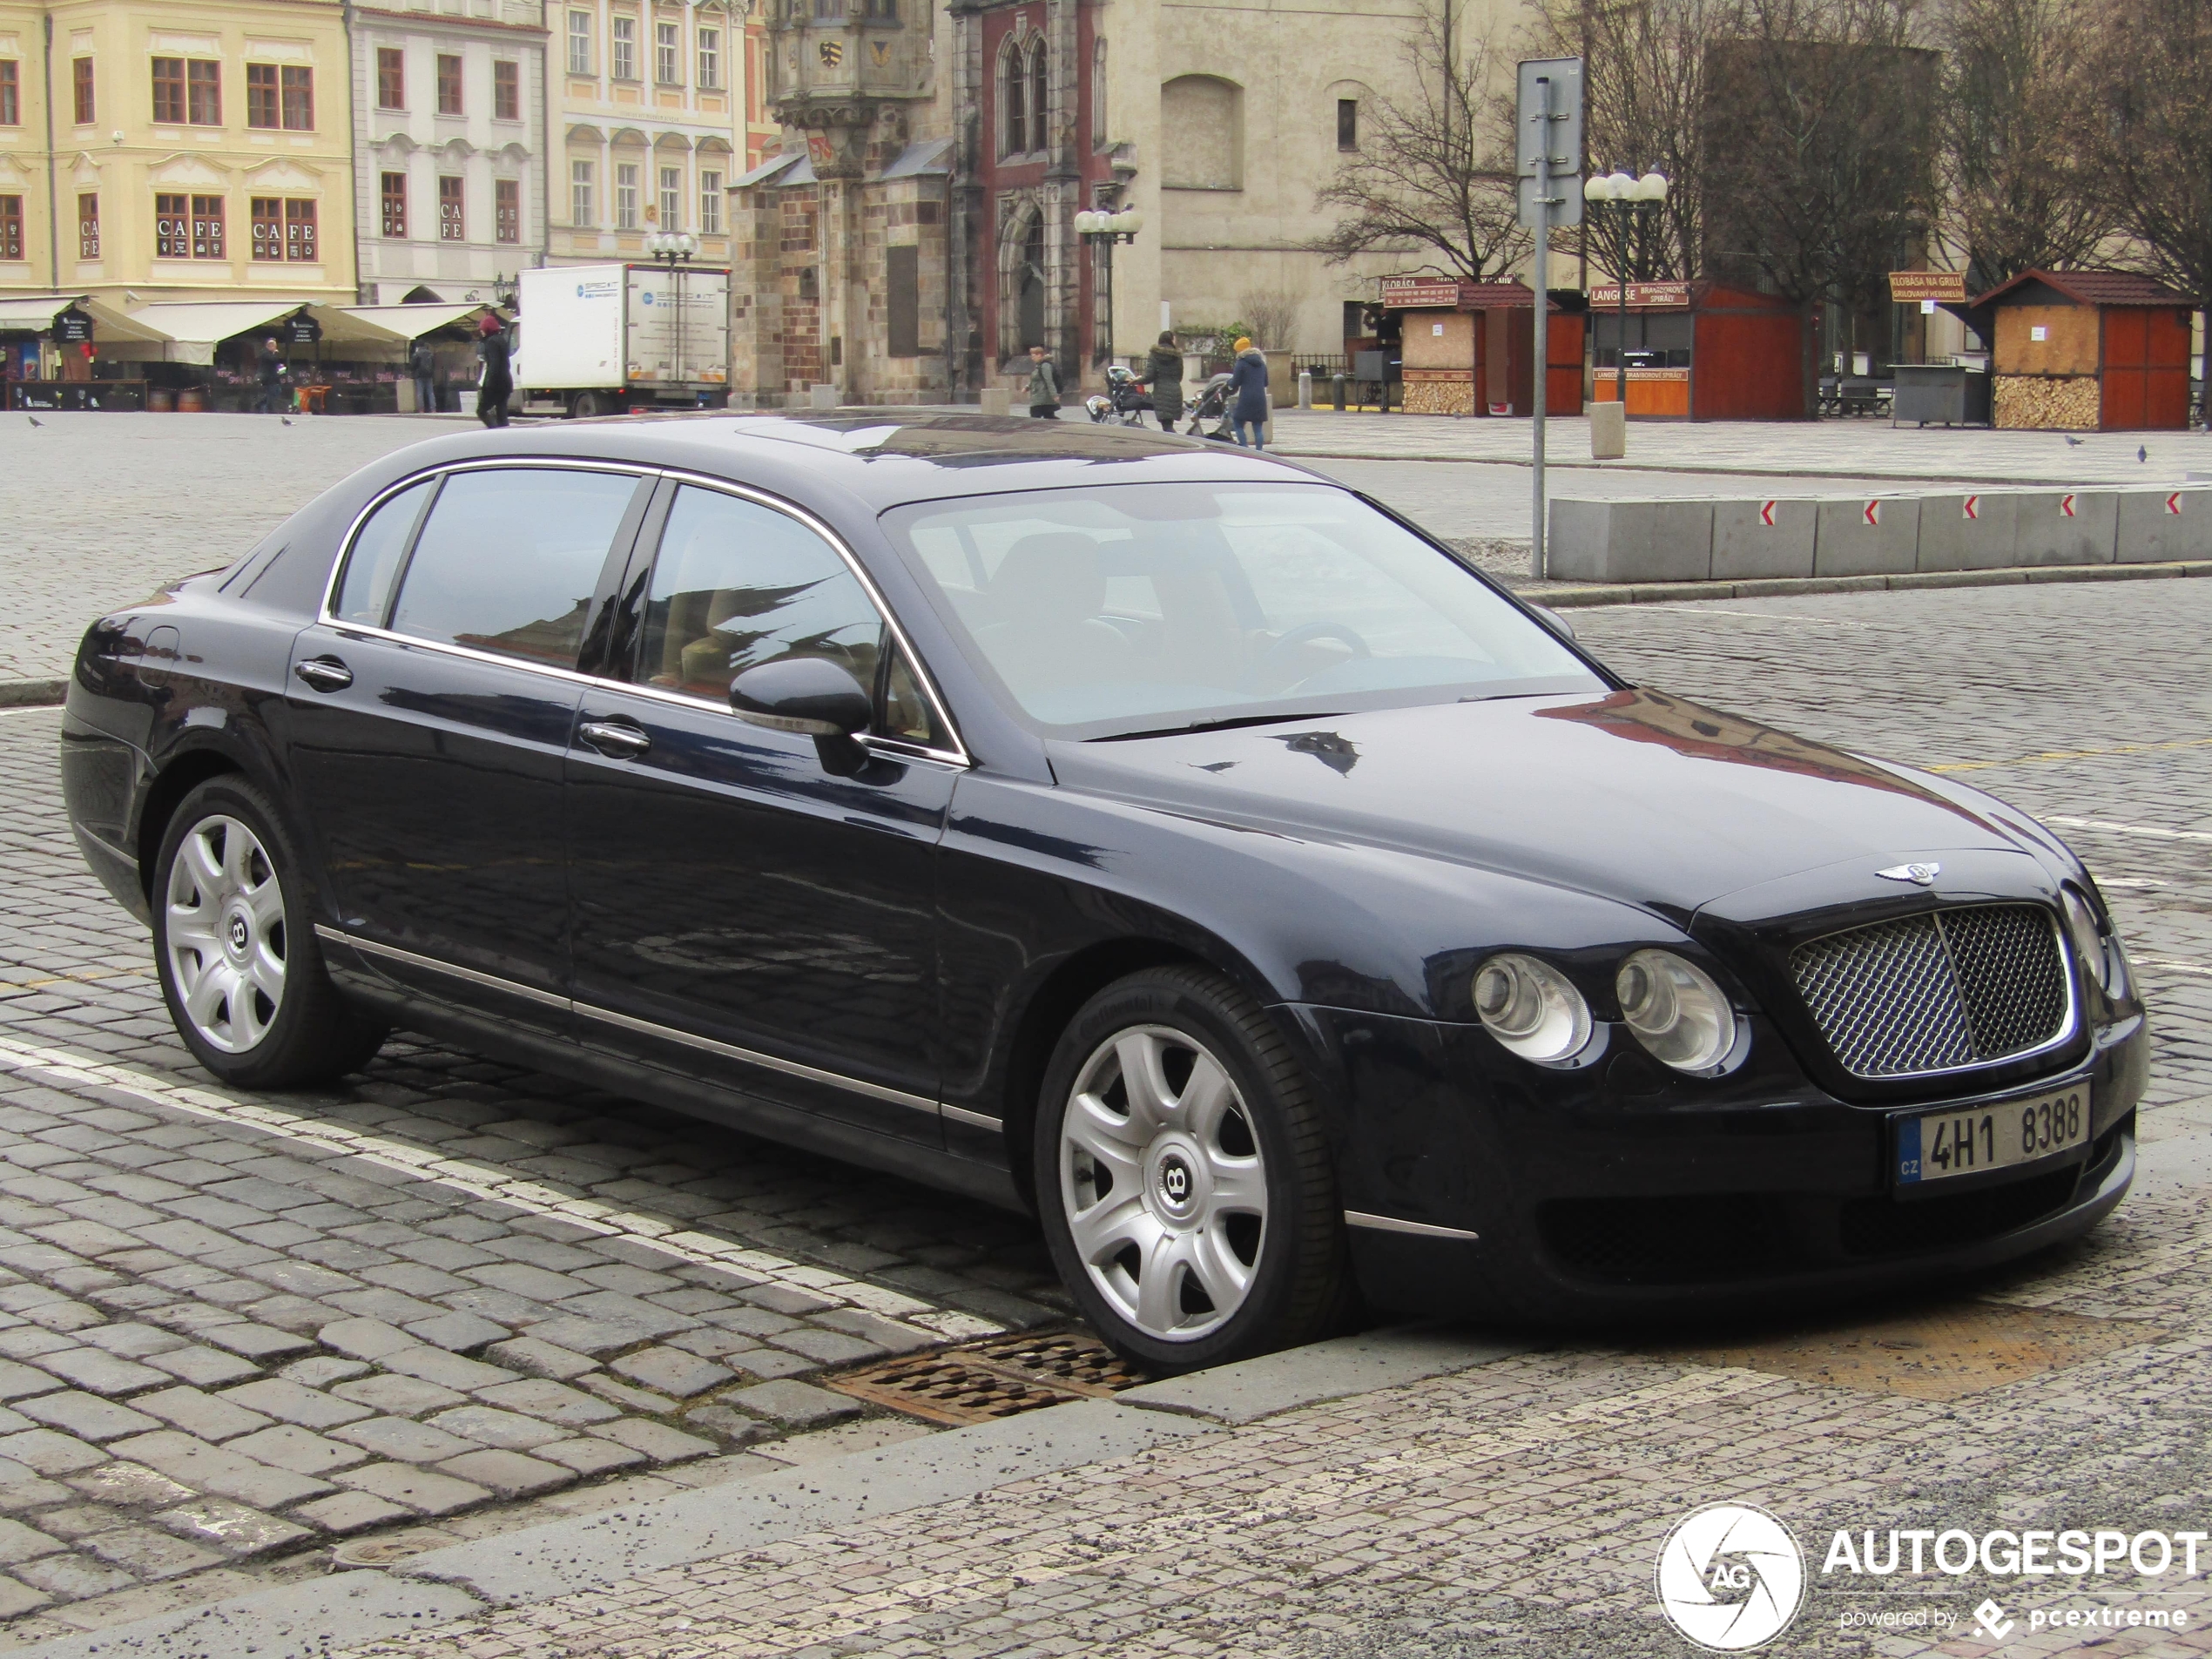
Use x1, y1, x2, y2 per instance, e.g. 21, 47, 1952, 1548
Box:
316, 455, 975, 770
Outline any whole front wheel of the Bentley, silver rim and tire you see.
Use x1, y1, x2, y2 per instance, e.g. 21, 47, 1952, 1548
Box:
1035, 969, 1352, 1372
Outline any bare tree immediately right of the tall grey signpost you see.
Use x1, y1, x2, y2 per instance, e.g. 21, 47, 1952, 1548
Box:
1533, 0, 1721, 281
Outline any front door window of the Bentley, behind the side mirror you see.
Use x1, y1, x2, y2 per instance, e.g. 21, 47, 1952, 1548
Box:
637, 484, 882, 708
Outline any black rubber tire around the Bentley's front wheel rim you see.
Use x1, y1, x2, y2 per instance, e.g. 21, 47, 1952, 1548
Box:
1033, 967, 1359, 1376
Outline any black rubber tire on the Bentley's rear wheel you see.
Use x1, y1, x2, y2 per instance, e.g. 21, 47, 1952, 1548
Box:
148, 774, 389, 1089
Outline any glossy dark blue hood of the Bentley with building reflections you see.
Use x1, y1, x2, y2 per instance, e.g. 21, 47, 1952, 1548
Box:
1051, 690, 2027, 922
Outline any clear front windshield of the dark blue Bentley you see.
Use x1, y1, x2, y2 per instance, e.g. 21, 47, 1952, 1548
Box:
885, 484, 1606, 738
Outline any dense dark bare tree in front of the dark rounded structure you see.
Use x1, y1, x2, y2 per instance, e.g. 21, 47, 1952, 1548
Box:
1703, 0, 1938, 416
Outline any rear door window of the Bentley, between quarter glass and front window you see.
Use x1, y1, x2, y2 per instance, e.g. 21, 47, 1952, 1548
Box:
389, 467, 637, 668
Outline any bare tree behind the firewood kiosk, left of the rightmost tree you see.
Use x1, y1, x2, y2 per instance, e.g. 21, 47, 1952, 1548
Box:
1938, 0, 2114, 292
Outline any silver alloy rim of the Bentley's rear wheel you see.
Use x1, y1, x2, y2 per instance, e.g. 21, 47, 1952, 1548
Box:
166, 816, 286, 1055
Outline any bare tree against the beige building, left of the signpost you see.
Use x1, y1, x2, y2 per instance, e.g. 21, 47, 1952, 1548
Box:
1314, 0, 1531, 283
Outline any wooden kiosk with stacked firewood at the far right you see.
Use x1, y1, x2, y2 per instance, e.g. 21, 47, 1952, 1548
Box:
1971, 270, 2196, 431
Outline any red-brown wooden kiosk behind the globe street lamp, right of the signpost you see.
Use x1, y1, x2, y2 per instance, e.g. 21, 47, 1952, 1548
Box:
1590, 283, 1805, 421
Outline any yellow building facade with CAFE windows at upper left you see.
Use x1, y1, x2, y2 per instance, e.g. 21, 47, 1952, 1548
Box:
0, 0, 356, 307
